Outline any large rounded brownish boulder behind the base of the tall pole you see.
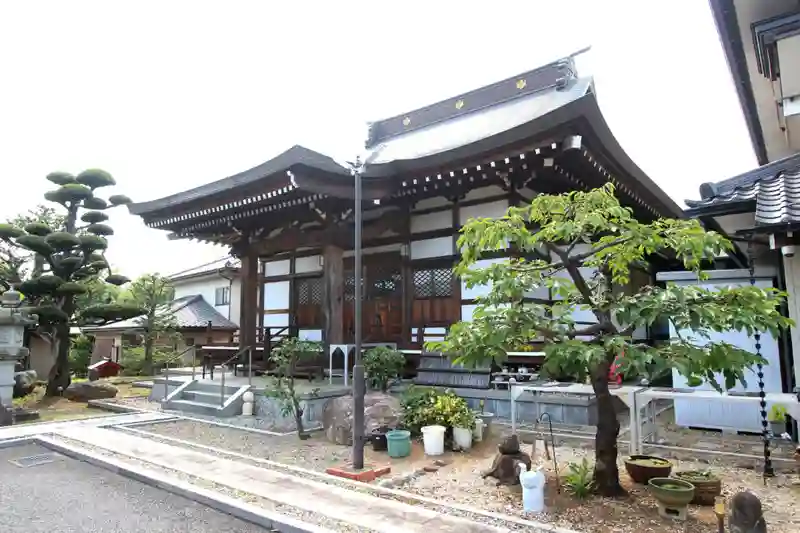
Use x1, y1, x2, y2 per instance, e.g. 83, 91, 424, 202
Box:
322, 392, 403, 446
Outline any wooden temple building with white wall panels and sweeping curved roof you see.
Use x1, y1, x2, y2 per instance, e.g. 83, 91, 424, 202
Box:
130, 53, 684, 366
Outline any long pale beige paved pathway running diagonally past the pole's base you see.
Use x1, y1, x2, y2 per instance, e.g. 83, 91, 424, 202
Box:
57, 427, 510, 533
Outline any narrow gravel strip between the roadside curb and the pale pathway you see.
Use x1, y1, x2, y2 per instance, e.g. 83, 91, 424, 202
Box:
51, 435, 373, 533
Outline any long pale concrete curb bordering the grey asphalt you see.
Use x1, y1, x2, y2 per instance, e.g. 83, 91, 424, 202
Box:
33, 436, 334, 533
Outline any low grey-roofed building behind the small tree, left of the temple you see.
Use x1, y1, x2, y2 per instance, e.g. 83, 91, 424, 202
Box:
83, 294, 239, 361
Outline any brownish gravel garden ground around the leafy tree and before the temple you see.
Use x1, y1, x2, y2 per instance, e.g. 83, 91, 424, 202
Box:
128, 421, 800, 533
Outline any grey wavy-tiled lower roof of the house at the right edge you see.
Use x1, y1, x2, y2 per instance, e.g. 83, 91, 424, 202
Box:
686, 154, 800, 226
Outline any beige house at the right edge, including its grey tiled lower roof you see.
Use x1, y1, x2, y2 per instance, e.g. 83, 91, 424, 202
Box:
686, 0, 800, 391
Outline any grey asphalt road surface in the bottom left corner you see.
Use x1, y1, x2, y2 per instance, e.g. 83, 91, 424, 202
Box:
0, 444, 267, 533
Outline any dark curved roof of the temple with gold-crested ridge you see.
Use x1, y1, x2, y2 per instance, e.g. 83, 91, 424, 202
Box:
129, 51, 683, 217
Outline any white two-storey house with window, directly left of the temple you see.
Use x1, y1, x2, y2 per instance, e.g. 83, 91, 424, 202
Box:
169, 257, 242, 324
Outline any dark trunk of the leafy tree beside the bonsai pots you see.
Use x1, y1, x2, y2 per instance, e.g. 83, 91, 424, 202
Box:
592, 361, 625, 497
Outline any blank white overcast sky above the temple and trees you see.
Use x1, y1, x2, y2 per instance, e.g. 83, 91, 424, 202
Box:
0, 0, 756, 276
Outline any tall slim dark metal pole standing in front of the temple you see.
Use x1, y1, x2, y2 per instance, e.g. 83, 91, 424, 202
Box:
353, 158, 366, 470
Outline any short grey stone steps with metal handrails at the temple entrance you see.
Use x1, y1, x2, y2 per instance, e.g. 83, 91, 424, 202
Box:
161, 380, 250, 417
